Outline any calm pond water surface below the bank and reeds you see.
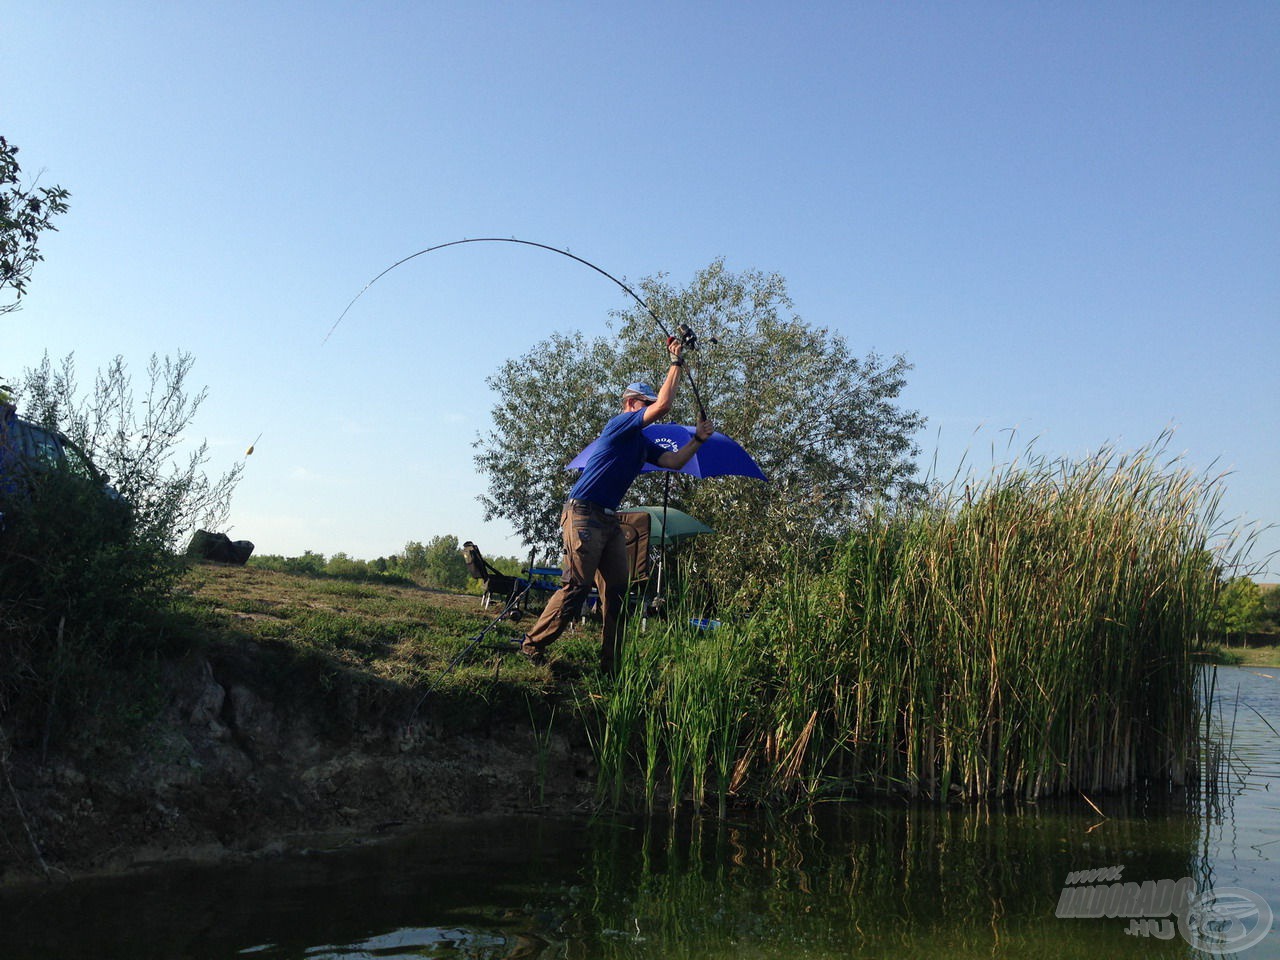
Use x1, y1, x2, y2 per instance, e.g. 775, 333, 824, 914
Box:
0, 668, 1280, 960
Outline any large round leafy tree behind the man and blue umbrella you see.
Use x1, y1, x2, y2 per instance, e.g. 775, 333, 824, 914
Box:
476, 260, 924, 604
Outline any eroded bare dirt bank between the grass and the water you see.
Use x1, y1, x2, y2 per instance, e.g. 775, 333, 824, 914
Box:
0, 646, 594, 883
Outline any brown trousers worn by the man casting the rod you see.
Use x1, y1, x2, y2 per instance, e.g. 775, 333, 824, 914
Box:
525, 500, 631, 673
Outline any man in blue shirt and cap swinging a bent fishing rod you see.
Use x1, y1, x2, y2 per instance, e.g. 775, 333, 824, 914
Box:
520, 338, 714, 675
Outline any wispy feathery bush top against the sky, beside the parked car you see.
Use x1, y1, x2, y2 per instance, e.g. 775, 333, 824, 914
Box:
19, 352, 244, 547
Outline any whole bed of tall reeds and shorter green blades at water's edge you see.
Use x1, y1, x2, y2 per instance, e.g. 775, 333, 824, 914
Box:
593, 443, 1221, 812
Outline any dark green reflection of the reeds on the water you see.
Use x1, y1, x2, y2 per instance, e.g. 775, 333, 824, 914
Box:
573, 808, 1196, 956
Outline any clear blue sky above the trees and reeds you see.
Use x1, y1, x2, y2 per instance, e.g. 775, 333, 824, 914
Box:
0, 0, 1280, 580
